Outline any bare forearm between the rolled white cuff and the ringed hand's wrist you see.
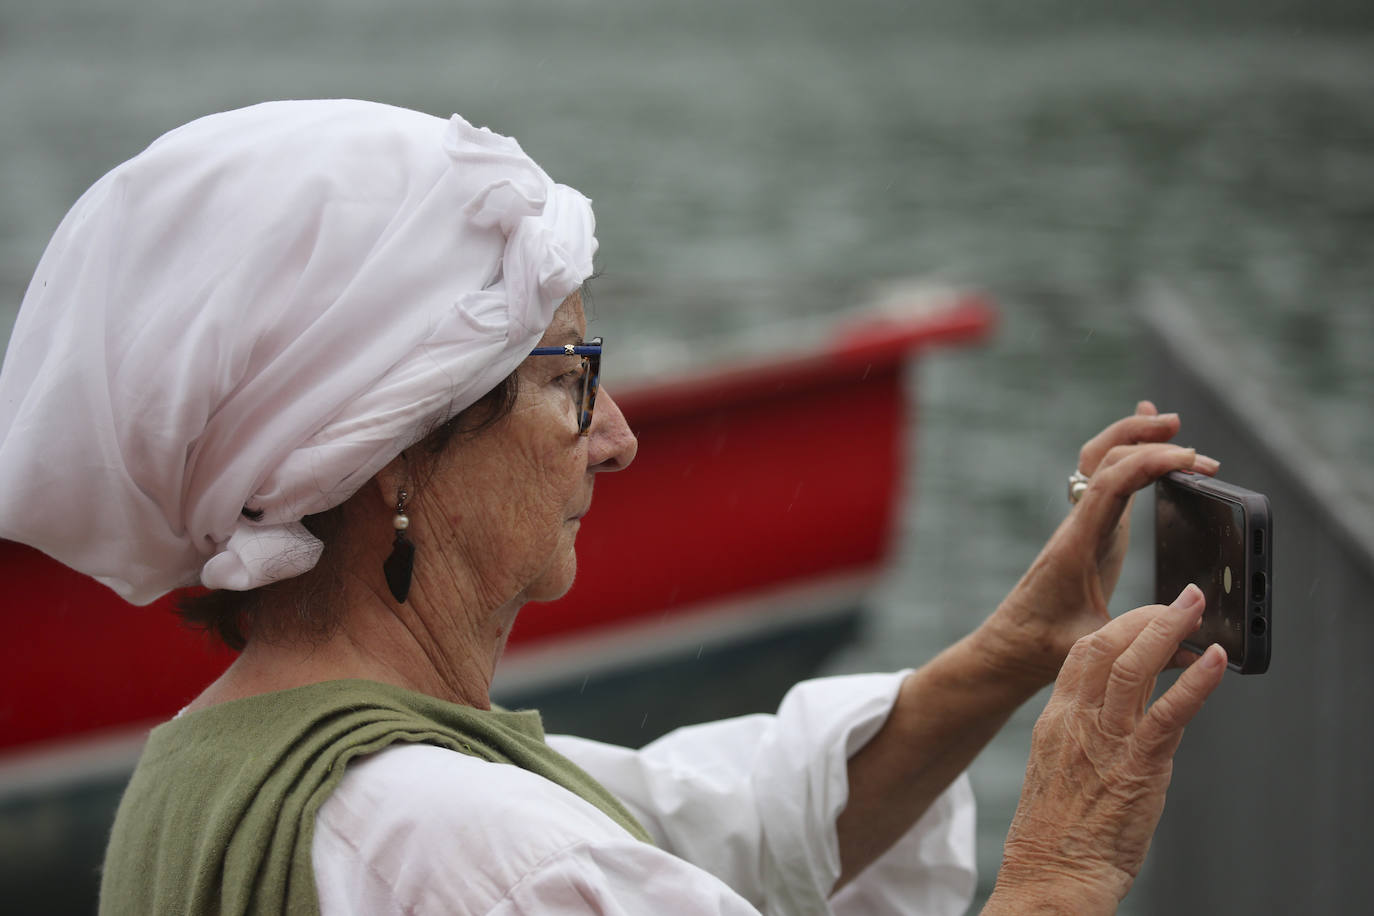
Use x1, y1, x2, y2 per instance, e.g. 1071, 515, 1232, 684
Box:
835, 615, 1044, 890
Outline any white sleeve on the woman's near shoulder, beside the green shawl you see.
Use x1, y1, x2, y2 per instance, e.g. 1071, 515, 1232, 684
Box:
311, 744, 758, 916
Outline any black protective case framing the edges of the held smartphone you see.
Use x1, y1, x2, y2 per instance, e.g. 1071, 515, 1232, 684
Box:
1154, 471, 1274, 674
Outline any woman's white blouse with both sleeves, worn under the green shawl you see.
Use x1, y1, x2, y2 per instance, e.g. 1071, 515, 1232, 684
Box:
312, 672, 976, 916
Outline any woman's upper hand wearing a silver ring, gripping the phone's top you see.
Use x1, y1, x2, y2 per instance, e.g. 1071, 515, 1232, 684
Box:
985, 401, 1219, 687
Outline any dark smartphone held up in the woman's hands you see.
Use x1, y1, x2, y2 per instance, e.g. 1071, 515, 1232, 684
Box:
1154, 471, 1274, 674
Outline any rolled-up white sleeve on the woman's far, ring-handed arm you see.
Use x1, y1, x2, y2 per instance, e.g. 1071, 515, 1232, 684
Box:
548, 672, 977, 916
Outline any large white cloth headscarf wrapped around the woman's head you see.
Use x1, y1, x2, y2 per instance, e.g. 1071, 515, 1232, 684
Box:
0, 100, 596, 604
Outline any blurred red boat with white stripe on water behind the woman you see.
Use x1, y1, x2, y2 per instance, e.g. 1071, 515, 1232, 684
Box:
0, 291, 993, 912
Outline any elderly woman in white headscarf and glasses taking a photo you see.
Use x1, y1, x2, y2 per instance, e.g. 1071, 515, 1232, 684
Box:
0, 102, 1224, 915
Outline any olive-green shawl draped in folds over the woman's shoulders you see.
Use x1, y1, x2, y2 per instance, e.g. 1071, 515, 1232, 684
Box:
100, 681, 651, 916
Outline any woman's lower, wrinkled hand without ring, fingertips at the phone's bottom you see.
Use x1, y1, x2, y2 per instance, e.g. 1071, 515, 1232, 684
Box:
982, 585, 1226, 916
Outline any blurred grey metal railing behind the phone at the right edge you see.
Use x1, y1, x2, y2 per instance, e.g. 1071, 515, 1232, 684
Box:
1132, 294, 1374, 916
